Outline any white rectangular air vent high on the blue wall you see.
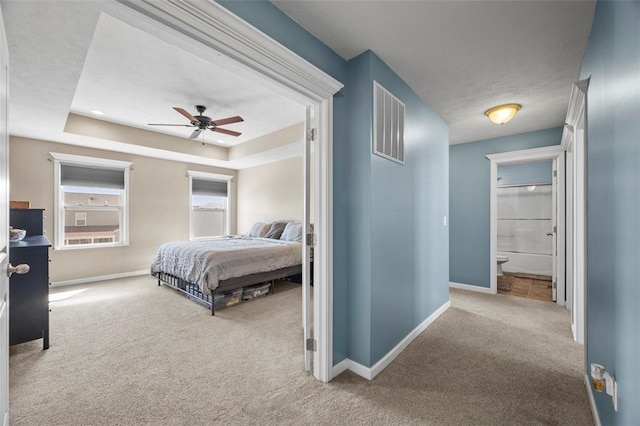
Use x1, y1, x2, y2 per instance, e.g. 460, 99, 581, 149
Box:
373, 81, 404, 164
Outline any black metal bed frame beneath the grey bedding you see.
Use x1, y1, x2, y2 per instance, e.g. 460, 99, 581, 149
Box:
155, 265, 302, 315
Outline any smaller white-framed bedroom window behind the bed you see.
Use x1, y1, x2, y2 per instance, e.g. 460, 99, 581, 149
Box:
189, 171, 232, 239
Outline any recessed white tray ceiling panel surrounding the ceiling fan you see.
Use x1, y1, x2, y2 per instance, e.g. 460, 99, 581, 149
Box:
71, 14, 305, 146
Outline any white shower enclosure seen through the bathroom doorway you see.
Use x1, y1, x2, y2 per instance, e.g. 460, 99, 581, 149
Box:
497, 183, 553, 276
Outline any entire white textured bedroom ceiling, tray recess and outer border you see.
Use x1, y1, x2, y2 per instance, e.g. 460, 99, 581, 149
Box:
2, 0, 305, 168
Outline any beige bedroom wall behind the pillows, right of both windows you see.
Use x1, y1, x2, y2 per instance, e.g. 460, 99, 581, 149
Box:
237, 157, 304, 234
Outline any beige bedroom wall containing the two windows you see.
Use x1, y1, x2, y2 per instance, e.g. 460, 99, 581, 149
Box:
10, 137, 237, 282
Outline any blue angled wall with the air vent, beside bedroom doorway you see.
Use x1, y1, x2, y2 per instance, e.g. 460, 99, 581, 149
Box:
220, 1, 448, 367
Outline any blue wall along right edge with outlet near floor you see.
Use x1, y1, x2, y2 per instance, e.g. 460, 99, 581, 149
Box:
581, 1, 640, 425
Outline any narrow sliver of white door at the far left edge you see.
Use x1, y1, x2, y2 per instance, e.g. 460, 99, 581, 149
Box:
0, 2, 9, 426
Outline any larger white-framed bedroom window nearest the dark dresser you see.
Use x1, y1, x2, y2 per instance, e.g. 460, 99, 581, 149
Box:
51, 152, 131, 250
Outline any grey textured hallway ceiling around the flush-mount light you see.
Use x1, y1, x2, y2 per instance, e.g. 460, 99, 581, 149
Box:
272, 0, 595, 143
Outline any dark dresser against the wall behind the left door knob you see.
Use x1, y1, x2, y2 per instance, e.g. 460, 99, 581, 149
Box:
9, 209, 51, 349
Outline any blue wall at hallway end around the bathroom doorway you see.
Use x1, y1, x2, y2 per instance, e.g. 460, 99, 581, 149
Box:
449, 127, 562, 288
